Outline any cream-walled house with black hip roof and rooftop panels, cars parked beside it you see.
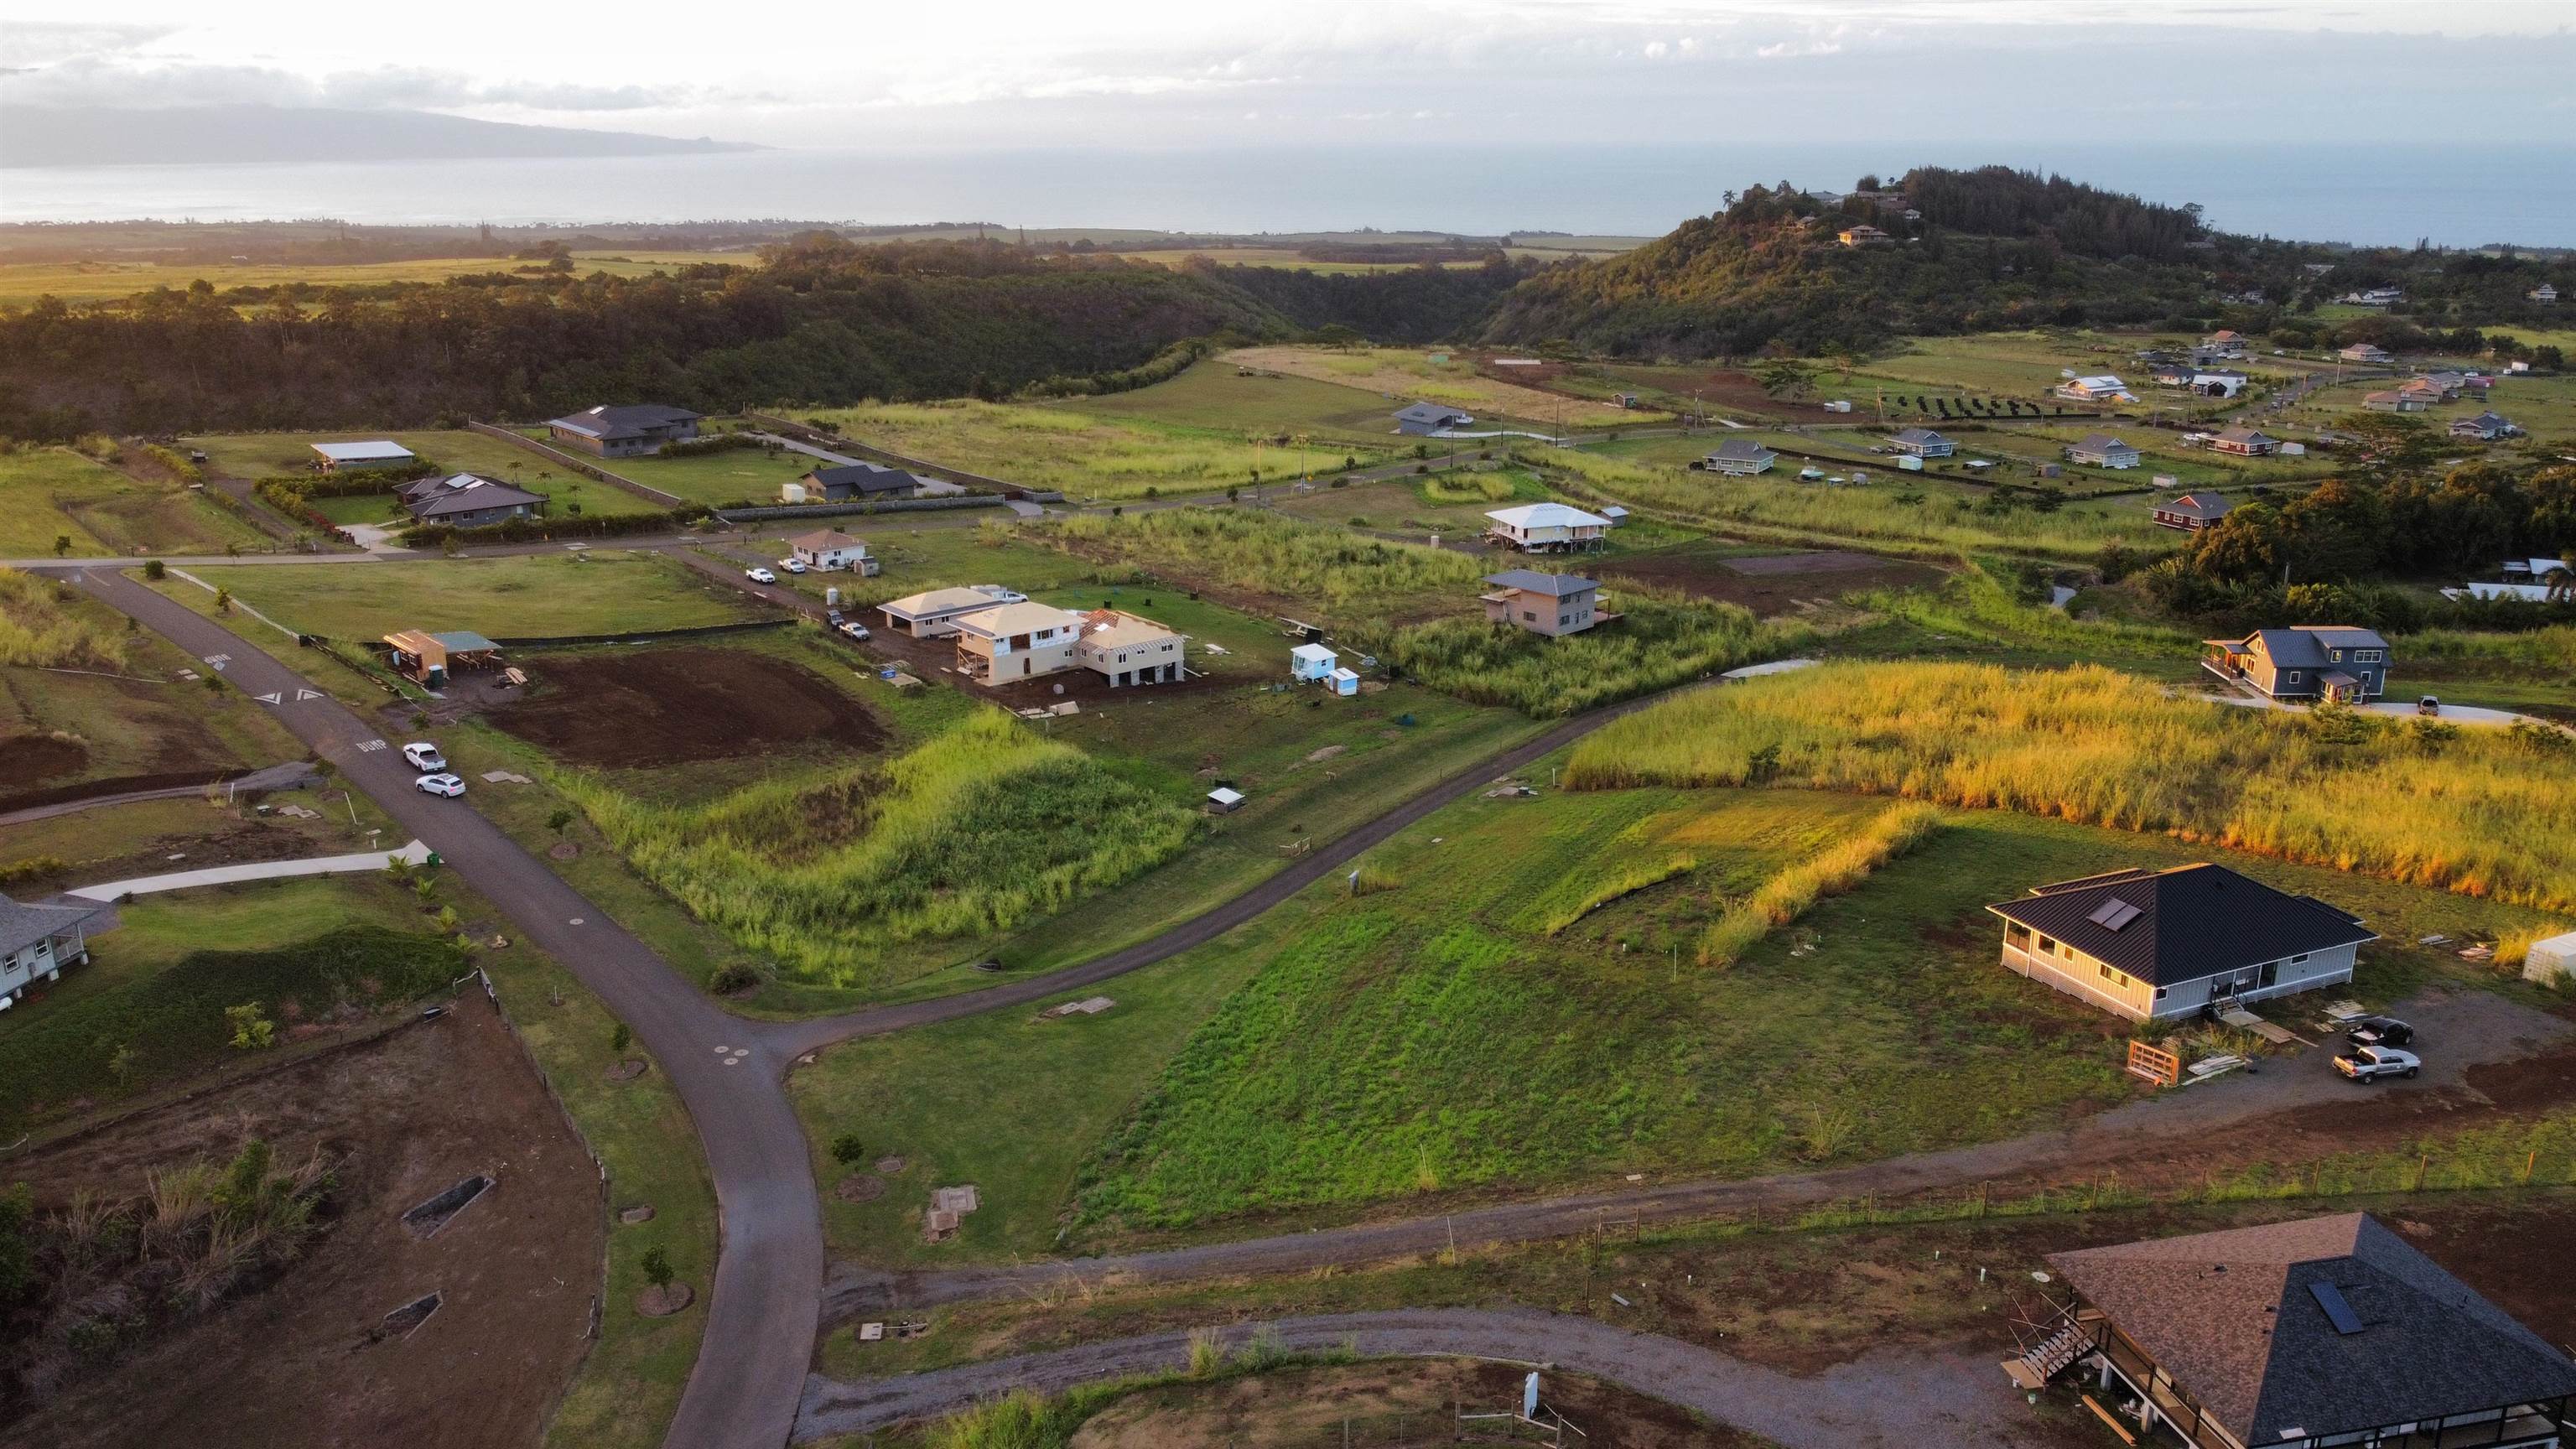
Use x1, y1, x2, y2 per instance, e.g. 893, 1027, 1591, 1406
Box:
1987, 861, 2377, 1021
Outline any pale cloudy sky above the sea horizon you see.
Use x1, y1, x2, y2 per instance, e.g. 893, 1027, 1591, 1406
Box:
0, 0, 2576, 150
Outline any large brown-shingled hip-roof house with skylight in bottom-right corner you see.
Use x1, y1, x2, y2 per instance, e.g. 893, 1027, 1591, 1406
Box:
2025, 1212, 2576, 1449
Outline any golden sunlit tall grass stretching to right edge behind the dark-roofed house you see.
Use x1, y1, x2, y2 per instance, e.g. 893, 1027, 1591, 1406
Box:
1564, 662, 2576, 910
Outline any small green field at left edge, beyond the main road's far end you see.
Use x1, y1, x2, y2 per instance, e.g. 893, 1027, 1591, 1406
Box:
0, 446, 267, 559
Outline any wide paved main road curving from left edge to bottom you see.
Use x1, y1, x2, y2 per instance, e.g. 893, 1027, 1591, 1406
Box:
46, 562, 822, 1449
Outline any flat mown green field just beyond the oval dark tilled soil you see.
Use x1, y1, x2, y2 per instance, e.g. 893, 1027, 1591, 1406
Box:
159, 549, 762, 642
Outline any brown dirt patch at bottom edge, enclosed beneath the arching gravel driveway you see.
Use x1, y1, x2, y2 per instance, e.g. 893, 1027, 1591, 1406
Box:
1074, 1358, 1759, 1449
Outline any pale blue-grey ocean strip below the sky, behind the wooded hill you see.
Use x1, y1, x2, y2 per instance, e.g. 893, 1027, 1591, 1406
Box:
0, 139, 2576, 247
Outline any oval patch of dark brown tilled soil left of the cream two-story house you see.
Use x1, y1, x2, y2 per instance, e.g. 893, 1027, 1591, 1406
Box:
490, 645, 886, 768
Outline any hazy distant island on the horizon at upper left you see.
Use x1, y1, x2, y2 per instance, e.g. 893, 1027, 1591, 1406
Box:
0, 106, 762, 168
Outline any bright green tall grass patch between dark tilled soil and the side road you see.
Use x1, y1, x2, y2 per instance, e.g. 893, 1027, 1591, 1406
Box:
551, 709, 1197, 985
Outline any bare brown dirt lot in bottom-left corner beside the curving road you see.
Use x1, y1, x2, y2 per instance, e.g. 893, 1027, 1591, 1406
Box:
8, 993, 605, 1449
